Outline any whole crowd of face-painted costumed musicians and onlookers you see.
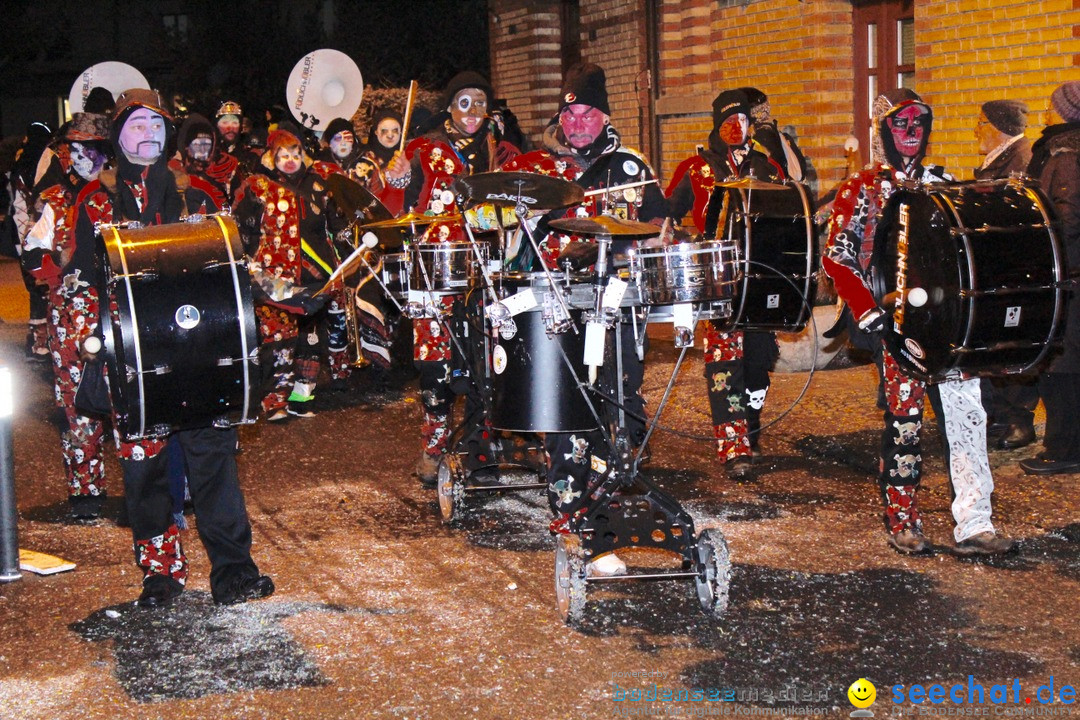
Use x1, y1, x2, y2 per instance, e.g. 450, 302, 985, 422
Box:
4, 63, 1080, 607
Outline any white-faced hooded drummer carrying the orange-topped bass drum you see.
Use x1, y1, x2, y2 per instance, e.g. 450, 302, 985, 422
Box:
71, 90, 274, 609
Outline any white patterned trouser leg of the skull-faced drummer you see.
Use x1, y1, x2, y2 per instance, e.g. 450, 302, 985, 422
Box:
939, 379, 994, 542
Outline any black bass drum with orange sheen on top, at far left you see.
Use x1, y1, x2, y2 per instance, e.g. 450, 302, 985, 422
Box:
102, 215, 259, 439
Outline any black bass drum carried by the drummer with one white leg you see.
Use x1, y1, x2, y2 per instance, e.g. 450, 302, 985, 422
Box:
873, 180, 1067, 380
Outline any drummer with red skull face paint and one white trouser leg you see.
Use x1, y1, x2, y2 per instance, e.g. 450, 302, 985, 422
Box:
822, 89, 1013, 554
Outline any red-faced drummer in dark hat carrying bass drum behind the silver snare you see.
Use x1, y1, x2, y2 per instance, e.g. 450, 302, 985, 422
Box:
667, 87, 790, 479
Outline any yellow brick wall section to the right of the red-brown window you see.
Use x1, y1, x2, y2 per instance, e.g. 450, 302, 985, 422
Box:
915, 0, 1080, 179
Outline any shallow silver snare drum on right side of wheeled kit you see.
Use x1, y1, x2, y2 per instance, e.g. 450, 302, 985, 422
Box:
630, 241, 737, 305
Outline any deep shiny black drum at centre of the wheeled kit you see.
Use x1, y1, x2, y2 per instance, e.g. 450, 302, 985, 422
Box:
490, 273, 597, 433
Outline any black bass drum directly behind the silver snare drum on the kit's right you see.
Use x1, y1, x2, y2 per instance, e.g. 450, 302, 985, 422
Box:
716, 182, 818, 332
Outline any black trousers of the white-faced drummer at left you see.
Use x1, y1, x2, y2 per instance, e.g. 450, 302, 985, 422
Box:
120, 427, 259, 596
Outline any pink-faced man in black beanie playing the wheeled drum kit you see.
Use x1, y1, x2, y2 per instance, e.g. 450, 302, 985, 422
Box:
502, 63, 667, 575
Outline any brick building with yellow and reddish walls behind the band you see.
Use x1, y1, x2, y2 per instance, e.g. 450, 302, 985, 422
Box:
489, 0, 1080, 197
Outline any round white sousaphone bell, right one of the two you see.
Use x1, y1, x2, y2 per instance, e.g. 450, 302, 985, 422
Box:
285, 50, 364, 131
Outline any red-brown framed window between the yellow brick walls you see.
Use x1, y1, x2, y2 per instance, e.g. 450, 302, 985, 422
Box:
852, 0, 916, 161
